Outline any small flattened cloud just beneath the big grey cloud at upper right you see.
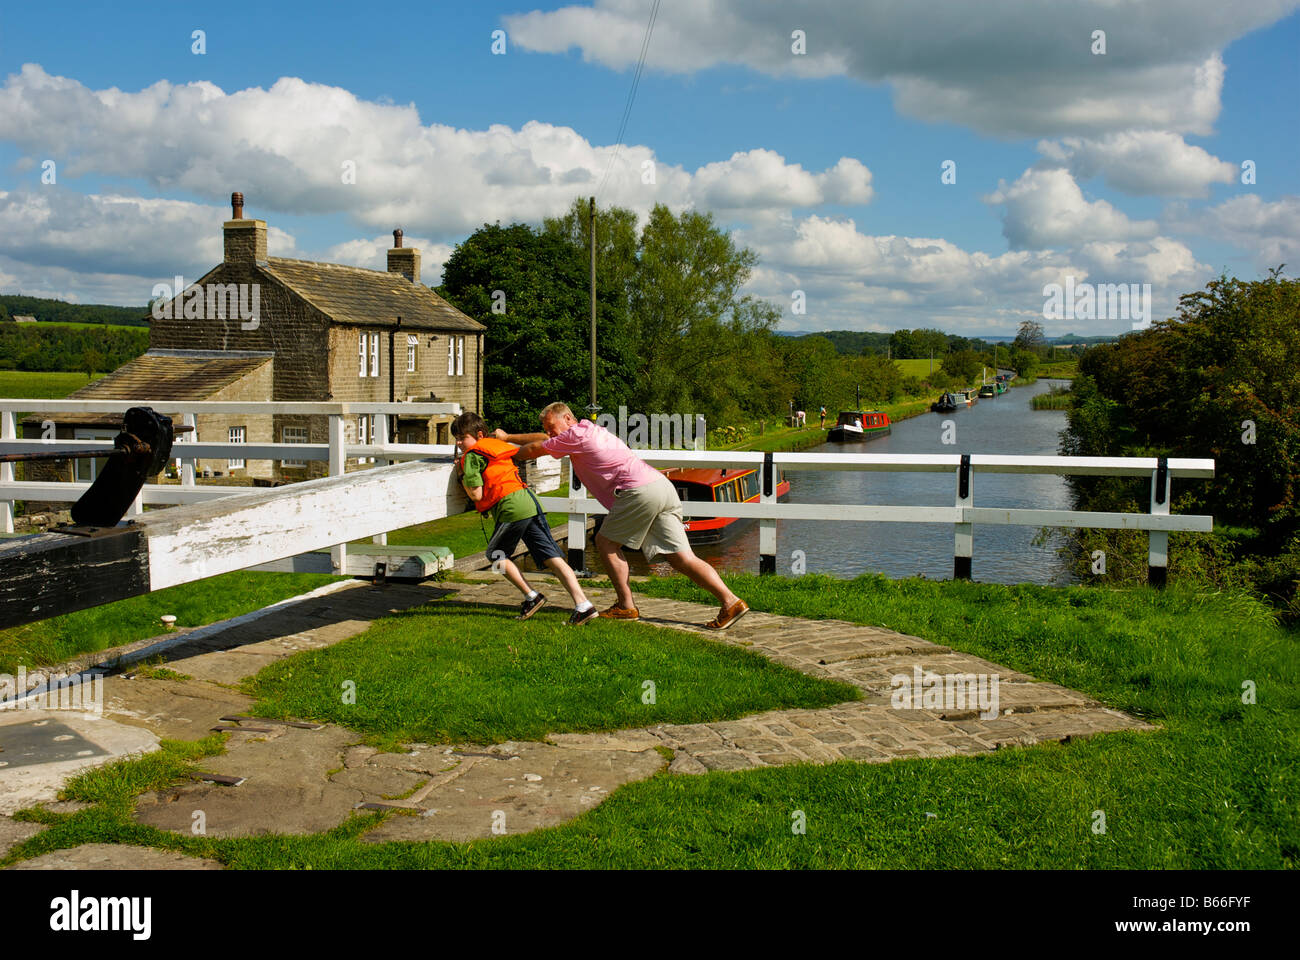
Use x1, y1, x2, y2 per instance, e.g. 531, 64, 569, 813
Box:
1039, 130, 1239, 196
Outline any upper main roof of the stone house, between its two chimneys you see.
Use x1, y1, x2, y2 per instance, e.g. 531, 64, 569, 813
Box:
261, 256, 488, 333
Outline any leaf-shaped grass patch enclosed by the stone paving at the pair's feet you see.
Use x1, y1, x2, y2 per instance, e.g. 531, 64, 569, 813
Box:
244, 587, 859, 747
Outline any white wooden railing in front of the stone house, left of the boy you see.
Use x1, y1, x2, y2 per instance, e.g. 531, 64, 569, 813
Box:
0, 398, 460, 570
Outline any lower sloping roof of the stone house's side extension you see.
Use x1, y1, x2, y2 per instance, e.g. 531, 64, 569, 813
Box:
23, 350, 273, 425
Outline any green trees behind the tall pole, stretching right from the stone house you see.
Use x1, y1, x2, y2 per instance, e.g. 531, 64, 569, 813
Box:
438, 199, 1071, 431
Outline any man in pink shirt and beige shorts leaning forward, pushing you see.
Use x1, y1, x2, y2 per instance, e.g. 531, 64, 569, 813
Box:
497, 403, 749, 630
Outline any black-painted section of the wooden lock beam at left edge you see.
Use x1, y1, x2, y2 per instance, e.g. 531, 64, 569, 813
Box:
0, 527, 150, 627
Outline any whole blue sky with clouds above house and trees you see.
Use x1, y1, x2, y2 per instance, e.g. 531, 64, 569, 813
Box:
0, 0, 1300, 336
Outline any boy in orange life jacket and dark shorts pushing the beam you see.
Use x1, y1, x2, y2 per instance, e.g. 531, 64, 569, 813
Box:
451, 414, 597, 627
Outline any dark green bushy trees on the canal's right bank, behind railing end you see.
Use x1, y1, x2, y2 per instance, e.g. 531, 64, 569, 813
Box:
1061, 267, 1300, 617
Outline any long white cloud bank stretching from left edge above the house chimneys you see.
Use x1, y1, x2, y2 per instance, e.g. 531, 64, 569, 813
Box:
0, 64, 871, 241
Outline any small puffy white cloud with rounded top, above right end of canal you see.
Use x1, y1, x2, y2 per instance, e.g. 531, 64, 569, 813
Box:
984, 169, 1158, 250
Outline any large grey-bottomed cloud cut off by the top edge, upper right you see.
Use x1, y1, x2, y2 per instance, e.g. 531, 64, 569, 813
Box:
503, 0, 1300, 137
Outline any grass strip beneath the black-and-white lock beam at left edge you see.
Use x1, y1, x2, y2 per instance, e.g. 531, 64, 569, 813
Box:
0, 570, 342, 674
